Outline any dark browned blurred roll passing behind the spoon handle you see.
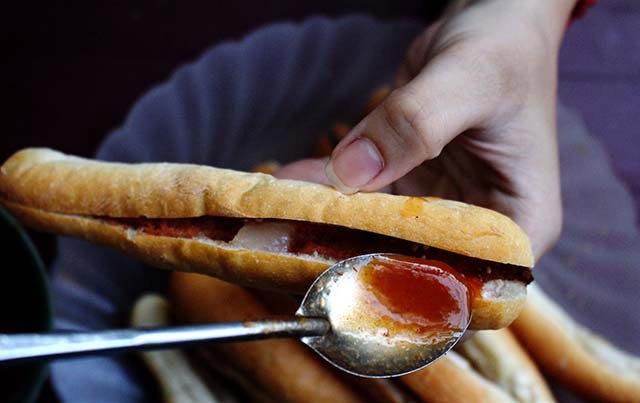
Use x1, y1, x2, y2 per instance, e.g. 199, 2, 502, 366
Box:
170, 273, 363, 403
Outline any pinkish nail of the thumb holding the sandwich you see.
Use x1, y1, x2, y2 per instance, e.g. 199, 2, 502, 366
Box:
326, 137, 384, 193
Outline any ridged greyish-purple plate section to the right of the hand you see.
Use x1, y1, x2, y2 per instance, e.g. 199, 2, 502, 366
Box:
534, 106, 640, 403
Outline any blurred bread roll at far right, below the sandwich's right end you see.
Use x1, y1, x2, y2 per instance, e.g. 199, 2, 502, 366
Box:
512, 285, 640, 403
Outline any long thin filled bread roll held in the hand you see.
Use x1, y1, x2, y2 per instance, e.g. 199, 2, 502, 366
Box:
0, 149, 533, 329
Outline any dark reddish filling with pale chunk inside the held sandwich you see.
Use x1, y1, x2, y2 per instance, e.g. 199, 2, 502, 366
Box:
105, 216, 533, 284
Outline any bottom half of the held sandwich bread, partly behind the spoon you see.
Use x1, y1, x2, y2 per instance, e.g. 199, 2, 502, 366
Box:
6, 202, 526, 330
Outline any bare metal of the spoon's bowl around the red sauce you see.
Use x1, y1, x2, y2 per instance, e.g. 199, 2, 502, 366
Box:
296, 253, 471, 378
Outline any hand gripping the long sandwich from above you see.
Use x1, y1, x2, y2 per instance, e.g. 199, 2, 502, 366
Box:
277, 0, 574, 257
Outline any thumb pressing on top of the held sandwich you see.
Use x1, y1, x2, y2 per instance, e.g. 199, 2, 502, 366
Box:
325, 61, 487, 193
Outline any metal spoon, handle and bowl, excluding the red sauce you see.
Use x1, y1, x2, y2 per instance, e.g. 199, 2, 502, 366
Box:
0, 254, 471, 377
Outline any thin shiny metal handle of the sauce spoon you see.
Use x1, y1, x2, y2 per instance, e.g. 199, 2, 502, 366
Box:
0, 317, 330, 364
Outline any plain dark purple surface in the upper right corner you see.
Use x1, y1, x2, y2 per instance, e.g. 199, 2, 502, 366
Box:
559, 0, 640, 224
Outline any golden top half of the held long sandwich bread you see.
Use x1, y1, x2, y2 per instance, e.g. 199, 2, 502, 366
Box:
0, 148, 534, 267
